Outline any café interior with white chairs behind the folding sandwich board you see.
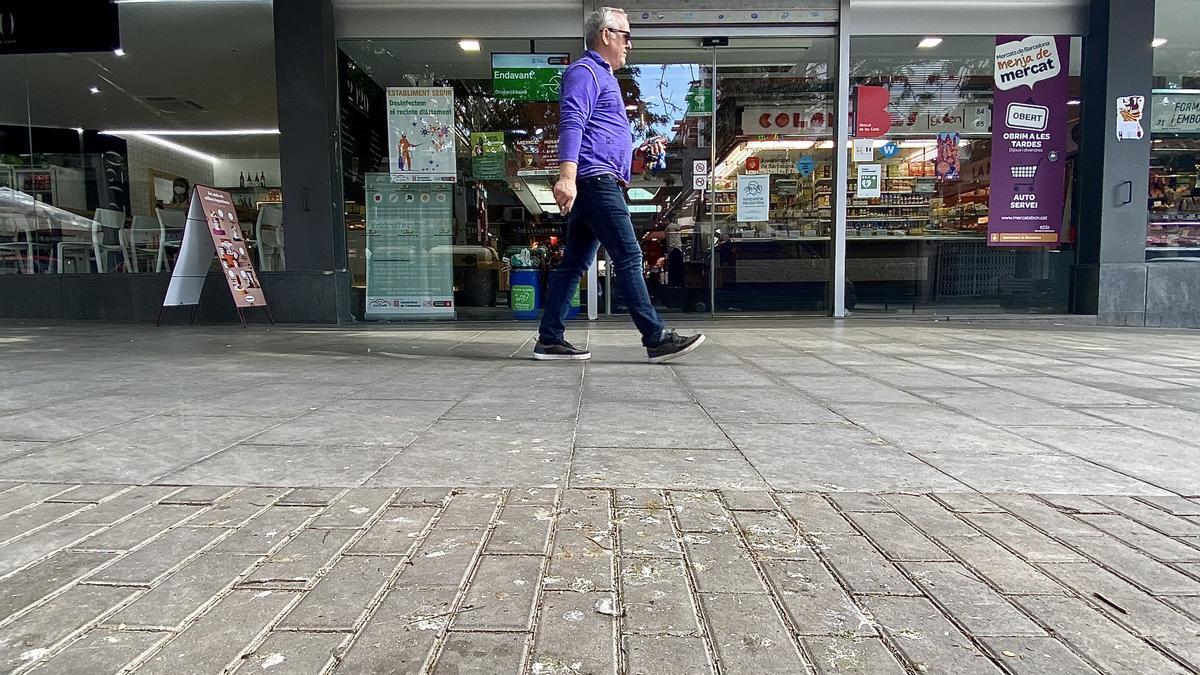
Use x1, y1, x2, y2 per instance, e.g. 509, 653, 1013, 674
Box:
0, 2, 280, 274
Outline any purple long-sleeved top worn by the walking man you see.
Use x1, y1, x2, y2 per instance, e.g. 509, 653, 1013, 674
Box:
558, 49, 634, 183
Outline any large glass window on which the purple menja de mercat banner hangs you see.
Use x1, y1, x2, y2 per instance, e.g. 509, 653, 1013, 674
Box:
846, 36, 1081, 313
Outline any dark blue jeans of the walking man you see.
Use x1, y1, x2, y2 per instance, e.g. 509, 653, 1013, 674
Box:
539, 175, 664, 347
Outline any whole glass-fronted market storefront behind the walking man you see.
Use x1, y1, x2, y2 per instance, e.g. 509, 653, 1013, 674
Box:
0, 0, 1200, 324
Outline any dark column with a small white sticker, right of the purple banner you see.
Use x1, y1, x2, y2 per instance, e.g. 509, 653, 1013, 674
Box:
1074, 0, 1154, 325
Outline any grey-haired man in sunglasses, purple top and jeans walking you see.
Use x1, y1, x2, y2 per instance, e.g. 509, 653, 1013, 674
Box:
533, 7, 704, 363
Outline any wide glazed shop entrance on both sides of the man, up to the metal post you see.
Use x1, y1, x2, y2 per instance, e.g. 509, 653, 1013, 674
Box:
340, 26, 836, 321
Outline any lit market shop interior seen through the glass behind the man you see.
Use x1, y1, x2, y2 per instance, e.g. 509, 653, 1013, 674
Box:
340, 30, 1099, 318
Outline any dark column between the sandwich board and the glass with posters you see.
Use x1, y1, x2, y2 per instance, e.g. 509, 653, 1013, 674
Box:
275, 0, 350, 323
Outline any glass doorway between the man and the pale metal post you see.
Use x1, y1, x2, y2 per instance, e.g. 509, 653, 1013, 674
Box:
600, 31, 836, 315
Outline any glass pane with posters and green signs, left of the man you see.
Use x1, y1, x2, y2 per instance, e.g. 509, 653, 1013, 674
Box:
338, 38, 582, 318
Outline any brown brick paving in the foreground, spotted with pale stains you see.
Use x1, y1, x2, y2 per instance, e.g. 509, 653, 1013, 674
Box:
0, 489, 1200, 674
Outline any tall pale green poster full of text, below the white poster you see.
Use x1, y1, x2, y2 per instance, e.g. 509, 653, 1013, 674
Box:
366, 173, 455, 319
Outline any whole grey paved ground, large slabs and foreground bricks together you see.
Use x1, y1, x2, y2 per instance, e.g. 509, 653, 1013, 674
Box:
0, 322, 1200, 675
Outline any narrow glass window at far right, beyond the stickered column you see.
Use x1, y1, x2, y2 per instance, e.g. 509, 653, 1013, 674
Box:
1146, 0, 1200, 259
